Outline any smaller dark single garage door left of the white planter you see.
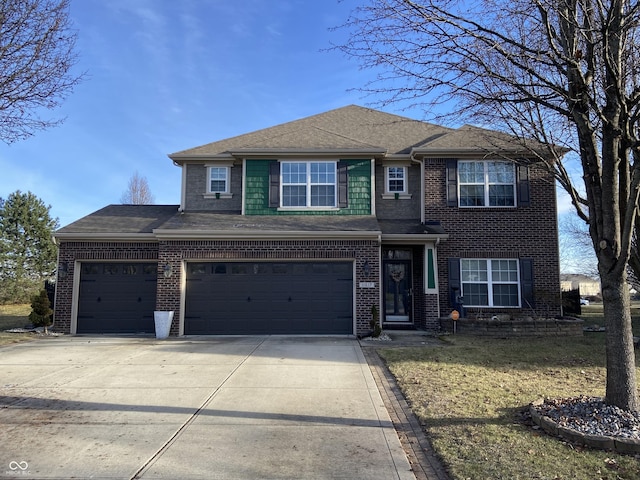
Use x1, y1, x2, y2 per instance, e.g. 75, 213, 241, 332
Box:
77, 263, 158, 333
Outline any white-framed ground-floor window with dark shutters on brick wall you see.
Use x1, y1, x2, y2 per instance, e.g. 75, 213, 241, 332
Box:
460, 258, 520, 307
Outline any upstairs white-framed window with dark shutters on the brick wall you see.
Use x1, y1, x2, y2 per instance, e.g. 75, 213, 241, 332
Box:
458, 161, 516, 207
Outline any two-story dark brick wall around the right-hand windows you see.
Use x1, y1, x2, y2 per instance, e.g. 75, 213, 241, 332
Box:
425, 159, 561, 317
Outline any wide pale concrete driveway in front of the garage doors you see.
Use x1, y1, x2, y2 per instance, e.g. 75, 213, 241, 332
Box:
0, 336, 415, 480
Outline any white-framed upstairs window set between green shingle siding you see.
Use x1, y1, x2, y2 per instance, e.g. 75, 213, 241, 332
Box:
280, 161, 338, 208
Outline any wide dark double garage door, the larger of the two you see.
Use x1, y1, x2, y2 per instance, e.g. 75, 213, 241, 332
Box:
184, 262, 353, 335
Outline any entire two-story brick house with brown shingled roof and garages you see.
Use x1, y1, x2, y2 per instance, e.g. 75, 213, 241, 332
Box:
55, 106, 560, 335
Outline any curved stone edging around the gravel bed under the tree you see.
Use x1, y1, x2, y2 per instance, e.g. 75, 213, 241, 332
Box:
529, 399, 640, 453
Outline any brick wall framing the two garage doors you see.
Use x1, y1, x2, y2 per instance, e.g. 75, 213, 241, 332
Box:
55, 240, 380, 336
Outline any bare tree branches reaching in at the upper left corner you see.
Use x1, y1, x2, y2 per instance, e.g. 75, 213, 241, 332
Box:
0, 0, 82, 144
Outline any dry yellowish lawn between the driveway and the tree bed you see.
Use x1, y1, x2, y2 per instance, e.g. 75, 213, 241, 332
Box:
380, 333, 640, 480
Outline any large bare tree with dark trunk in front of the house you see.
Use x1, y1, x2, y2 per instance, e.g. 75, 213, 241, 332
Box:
338, 0, 640, 411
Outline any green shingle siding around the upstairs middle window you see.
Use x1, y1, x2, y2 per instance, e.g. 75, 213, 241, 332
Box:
244, 159, 371, 215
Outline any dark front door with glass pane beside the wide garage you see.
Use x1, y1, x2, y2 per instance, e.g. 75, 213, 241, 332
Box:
383, 259, 413, 323
